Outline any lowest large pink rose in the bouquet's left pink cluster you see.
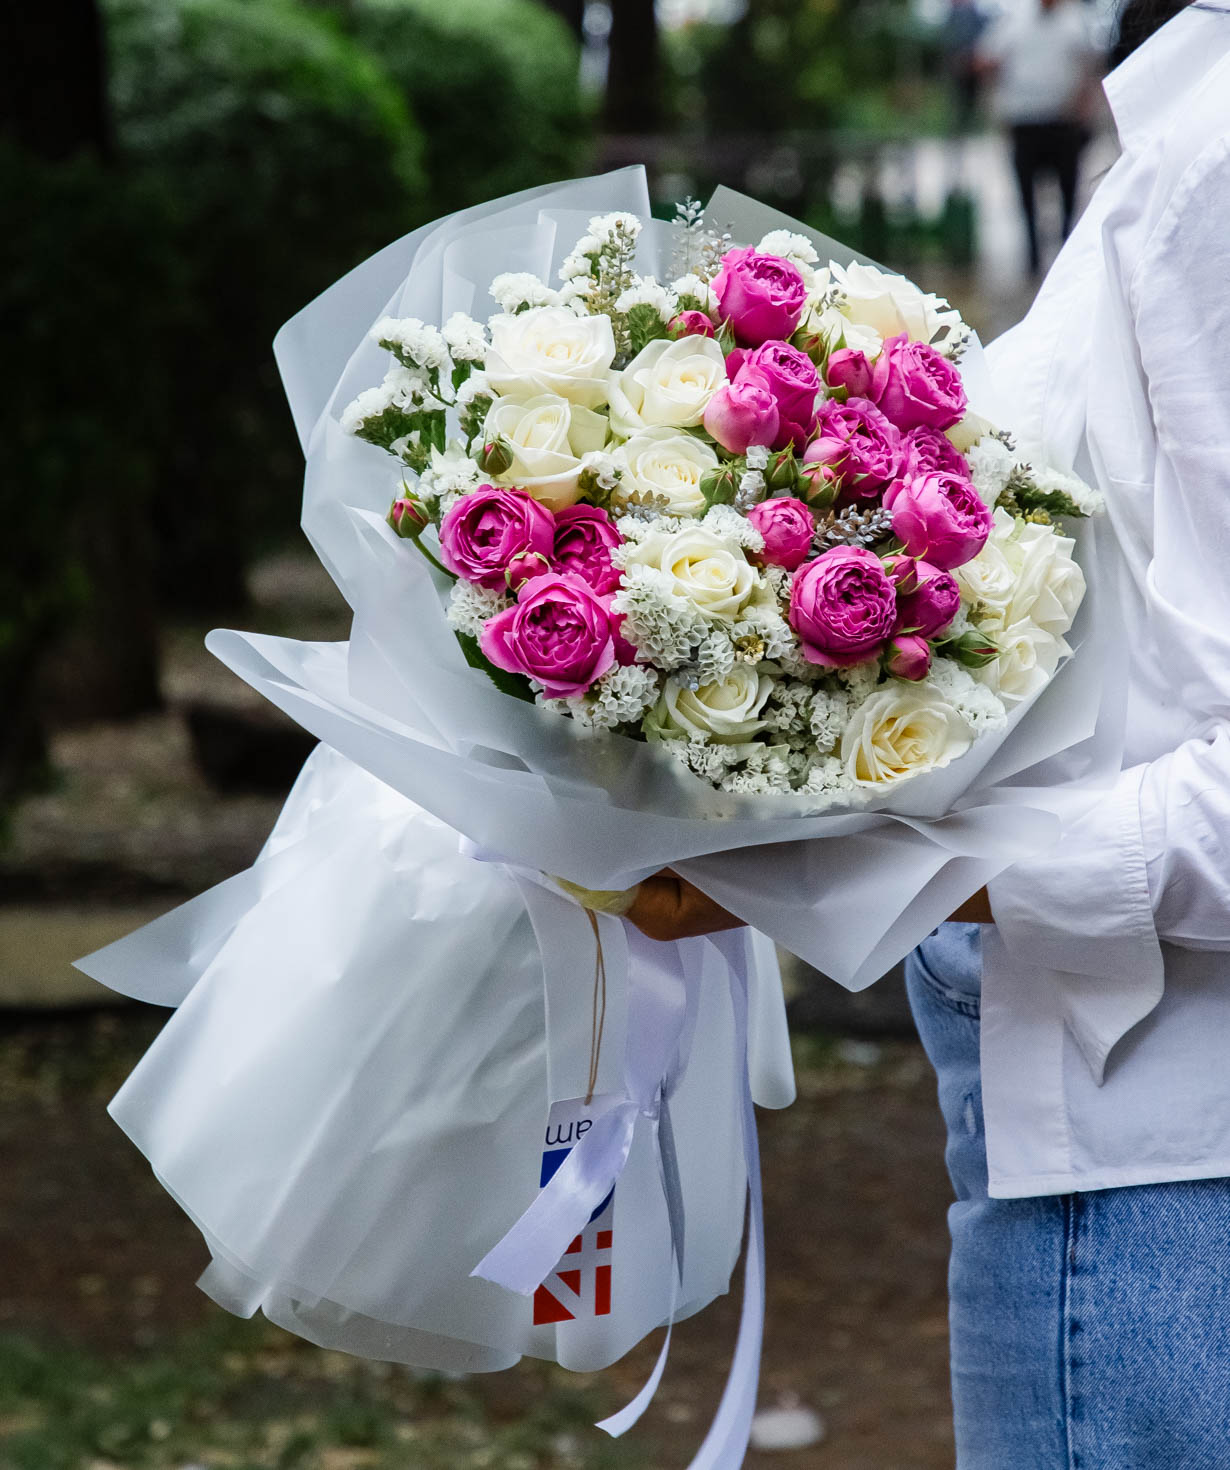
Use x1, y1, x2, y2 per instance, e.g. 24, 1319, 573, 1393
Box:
479, 572, 616, 700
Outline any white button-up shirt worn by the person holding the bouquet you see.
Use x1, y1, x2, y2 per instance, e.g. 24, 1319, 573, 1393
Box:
982, 0, 1230, 1197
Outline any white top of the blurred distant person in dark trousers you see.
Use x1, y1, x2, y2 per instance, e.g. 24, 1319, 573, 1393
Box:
979, 0, 1098, 123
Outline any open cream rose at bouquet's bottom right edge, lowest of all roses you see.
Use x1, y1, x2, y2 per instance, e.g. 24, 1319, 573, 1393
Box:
841, 679, 973, 789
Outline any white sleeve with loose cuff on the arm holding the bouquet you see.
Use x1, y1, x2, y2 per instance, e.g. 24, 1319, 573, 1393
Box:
989, 137, 1230, 1078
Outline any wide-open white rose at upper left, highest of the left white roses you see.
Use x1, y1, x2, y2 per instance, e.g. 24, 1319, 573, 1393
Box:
485, 306, 614, 409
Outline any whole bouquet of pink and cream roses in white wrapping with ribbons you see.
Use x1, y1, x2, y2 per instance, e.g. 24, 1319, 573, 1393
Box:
84, 169, 1117, 1467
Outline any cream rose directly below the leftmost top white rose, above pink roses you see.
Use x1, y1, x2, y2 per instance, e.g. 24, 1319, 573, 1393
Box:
483, 392, 607, 510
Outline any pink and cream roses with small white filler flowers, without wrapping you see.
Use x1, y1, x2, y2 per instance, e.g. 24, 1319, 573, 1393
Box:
342, 206, 1098, 810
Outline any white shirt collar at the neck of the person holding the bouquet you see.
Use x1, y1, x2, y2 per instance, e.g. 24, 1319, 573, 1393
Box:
1102, 0, 1230, 147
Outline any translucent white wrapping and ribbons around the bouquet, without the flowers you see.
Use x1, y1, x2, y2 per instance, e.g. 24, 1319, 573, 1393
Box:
82, 169, 1121, 1470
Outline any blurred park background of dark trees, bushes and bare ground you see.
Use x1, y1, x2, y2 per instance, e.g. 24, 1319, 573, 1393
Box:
0, 0, 1117, 1470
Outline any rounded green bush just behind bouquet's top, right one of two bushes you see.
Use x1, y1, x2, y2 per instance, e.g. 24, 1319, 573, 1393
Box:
331, 0, 589, 215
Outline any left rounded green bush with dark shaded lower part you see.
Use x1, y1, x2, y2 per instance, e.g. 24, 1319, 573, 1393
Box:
104, 0, 426, 613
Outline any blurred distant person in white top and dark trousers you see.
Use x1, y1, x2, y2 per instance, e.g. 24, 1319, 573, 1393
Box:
977, 0, 1102, 276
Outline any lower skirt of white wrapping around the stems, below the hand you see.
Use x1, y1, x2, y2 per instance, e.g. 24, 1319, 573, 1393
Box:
88, 745, 792, 1372
